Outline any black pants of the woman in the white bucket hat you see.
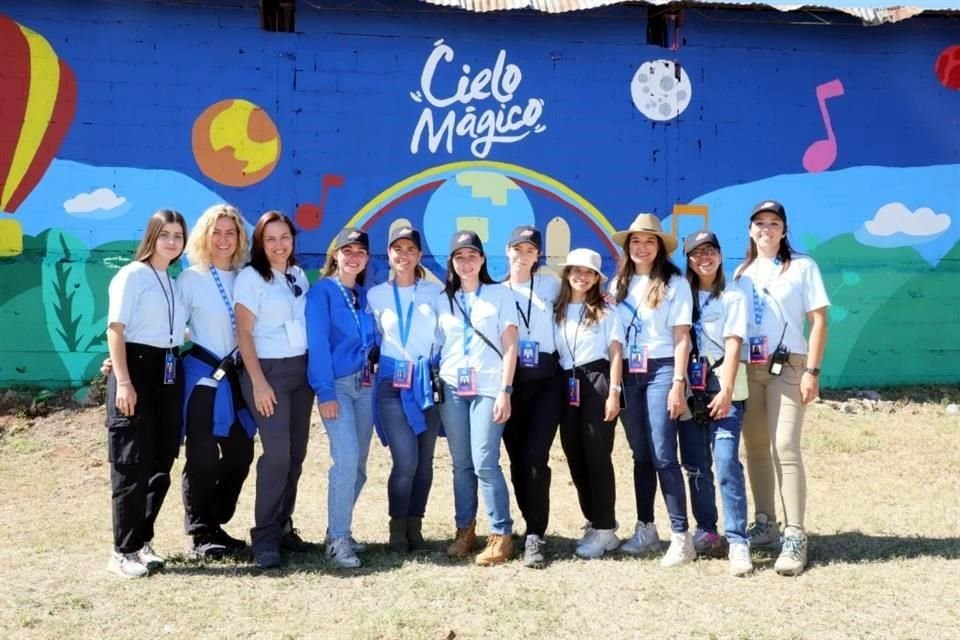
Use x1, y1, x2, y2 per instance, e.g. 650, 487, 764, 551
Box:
560, 360, 616, 529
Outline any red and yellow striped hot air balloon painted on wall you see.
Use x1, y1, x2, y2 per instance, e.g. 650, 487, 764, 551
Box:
0, 15, 77, 256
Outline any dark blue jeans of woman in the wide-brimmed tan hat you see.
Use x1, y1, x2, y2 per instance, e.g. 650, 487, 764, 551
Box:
620, 358, 688, 533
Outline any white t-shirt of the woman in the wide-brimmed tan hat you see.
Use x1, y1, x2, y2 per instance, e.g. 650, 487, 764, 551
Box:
610, 274, 693, 358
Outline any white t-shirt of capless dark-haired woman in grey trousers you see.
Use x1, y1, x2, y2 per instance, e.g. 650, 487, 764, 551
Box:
233, 266, 309, 358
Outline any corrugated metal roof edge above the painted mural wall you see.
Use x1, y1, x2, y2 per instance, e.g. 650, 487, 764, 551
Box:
412, 0, 960, 25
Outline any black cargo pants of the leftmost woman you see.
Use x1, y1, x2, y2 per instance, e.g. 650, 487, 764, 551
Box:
107, 342, 183, 553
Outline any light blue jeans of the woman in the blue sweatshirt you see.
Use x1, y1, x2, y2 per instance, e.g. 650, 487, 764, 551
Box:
323, 371, 373, 539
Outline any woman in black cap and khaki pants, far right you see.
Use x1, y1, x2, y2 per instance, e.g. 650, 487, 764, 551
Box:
734, 200, 830, 576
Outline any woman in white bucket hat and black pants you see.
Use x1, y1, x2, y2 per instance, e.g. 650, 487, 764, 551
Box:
554, 249, 623, 558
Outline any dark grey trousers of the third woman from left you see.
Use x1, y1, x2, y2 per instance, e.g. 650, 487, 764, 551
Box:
240, 355, 314, 552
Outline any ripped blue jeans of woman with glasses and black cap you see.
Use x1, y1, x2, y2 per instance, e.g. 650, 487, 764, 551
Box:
680, 401, 747, 542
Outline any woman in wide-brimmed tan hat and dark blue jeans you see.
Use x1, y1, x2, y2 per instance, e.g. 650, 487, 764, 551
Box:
610, 213, 696, 566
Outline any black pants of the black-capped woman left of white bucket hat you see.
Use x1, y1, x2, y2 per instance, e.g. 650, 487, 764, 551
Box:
503, 370, 564, 537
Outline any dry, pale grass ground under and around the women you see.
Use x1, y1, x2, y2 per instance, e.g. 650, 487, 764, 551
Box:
0, 391, 960, 639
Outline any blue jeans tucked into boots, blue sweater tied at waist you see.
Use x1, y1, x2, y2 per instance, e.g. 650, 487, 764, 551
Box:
377, 380, 440, 518
